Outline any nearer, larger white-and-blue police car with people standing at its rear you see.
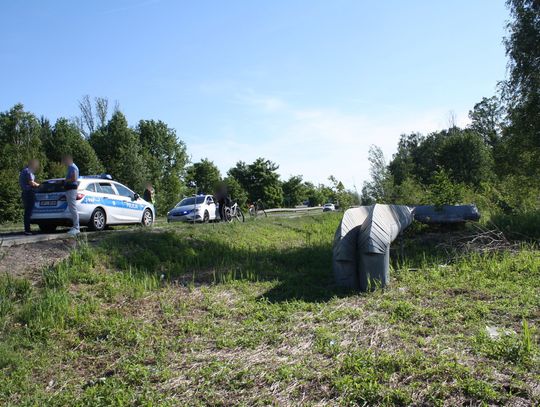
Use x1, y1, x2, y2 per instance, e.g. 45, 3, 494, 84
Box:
31, 174, 156, 232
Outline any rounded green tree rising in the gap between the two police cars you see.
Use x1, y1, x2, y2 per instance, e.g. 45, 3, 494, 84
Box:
136, 120, 188, 213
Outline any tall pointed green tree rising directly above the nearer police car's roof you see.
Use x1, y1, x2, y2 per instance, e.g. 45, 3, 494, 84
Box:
89, 112, 148, 191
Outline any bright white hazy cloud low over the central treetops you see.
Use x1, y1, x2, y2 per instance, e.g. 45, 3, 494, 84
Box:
185, 91, 466, 189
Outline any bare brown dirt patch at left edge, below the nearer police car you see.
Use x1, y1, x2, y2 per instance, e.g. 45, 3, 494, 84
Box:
0, 239, 77, 281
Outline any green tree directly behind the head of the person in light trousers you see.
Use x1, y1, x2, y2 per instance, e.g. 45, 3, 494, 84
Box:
41, 118, 103, 176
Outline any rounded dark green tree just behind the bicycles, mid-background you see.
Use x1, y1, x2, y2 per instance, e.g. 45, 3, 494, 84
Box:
228, 158, 283, 208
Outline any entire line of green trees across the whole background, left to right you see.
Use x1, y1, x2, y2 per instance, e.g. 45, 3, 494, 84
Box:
0, 0, 540, 222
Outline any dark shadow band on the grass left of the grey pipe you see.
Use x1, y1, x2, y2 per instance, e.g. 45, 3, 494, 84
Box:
98, 228, 448, 302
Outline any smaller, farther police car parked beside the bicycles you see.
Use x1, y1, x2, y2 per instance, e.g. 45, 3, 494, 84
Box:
167, 195, 219, 222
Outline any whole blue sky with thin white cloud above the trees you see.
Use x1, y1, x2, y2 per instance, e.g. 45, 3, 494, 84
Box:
0, 0, 508, 188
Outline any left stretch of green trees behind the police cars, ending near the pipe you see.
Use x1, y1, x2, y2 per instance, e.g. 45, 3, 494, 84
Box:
0, 96, 358, 222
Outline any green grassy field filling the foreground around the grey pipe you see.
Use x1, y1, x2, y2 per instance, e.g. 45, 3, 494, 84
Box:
0, 214, 540, 406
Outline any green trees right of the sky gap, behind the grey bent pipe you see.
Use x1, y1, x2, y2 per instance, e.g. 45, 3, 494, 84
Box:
362, 0, 540, 220
